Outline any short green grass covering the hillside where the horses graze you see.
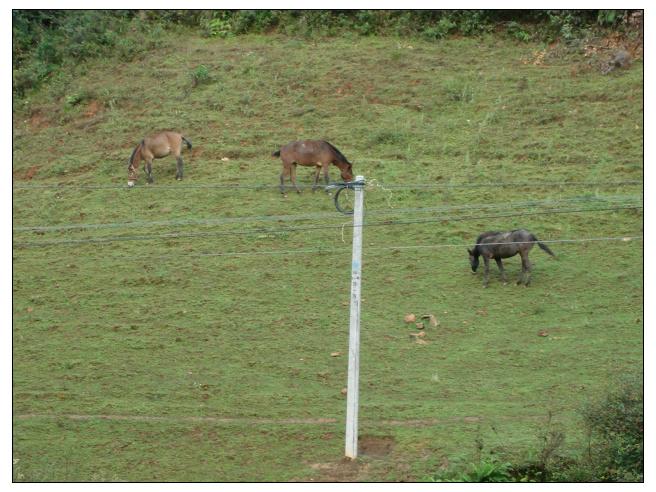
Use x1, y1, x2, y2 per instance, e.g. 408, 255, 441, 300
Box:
13, 35, 643, 481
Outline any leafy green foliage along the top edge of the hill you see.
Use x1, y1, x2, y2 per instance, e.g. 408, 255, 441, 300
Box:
12, 10, 642, 97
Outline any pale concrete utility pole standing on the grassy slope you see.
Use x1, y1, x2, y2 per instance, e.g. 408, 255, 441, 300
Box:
345, 176, 364, 459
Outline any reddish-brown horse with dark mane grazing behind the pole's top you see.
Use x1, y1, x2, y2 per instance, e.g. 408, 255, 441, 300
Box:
271, 140, 353, 194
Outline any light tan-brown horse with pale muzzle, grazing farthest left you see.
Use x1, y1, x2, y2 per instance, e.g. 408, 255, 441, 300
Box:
128, 132, 191, 187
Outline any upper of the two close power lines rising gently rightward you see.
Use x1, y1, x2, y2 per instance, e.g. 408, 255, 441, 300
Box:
13, 196, 640, 232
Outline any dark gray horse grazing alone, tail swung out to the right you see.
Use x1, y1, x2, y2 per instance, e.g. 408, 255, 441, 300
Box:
467, 229, 556, 287
